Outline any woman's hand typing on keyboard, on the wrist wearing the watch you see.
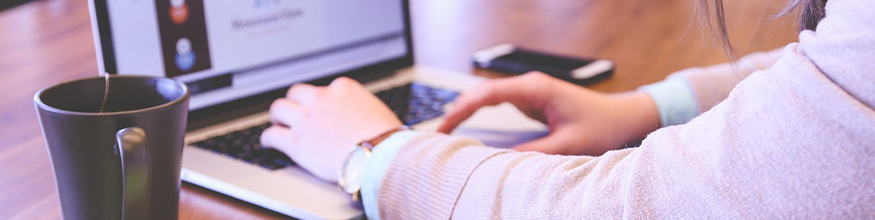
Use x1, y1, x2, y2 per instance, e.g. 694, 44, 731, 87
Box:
261, 77, 401, 182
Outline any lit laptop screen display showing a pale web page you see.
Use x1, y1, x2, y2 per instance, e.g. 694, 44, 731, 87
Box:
91, 0, 412, 110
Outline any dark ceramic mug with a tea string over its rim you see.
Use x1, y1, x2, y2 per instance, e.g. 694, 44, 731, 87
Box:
34, 76, 190, 220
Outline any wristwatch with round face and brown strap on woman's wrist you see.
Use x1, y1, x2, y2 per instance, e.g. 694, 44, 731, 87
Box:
337, 126, 410, 202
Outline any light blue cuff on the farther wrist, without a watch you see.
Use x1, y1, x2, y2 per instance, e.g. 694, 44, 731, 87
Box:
638, 78, 699, 127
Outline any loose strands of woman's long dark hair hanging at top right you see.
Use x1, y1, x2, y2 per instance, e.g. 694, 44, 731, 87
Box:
699, 0, 827, 60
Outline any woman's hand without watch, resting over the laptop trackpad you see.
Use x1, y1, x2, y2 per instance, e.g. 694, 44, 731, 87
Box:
438, 72, 659, 155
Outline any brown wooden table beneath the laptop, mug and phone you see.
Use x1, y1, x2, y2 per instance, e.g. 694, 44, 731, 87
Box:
0, 0, 796, 219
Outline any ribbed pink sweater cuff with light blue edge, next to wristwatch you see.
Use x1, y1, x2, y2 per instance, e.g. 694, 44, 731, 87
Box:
362, 131, 510, 219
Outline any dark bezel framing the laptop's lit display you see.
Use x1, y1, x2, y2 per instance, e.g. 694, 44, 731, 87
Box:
88, 0, 414, 130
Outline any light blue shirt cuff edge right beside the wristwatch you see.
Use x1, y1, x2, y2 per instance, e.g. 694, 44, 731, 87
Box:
361, 131, 423, 220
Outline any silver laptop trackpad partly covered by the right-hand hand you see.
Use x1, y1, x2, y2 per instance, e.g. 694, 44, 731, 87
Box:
453, 103, 549, 148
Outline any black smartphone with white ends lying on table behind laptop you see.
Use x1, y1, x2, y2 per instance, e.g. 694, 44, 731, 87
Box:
473, 44, 614, 84
